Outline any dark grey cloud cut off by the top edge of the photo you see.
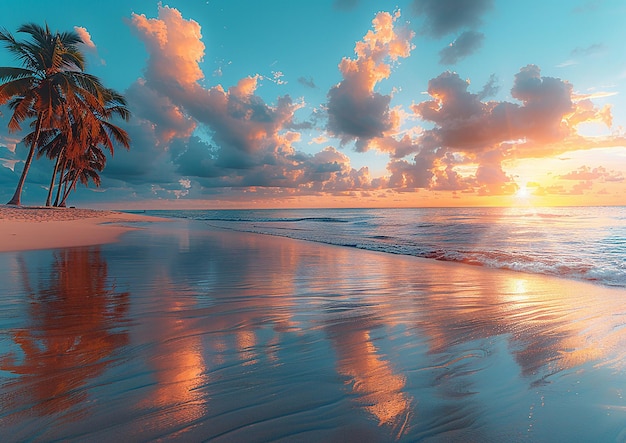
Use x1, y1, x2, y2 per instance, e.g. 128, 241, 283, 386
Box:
413, 0, 494, 38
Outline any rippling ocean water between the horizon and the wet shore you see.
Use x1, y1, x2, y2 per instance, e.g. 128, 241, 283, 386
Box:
147, 206, 626, 288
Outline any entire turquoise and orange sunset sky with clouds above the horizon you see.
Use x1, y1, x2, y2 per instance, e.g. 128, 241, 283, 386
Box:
0, 0, 626, 209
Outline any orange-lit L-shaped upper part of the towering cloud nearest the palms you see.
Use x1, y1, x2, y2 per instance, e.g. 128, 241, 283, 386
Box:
132, 7, 302, 161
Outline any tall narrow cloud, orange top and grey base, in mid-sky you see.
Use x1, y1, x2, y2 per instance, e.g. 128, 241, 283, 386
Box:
327, 12, 413, 151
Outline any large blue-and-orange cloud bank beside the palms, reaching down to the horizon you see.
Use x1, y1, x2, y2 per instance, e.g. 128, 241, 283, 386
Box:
107, 6, 382, 198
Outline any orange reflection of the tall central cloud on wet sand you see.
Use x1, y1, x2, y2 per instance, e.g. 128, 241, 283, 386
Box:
287, 243, 415, 438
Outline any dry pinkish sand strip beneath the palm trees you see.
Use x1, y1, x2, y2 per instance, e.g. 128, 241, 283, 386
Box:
0, 205, 164, 252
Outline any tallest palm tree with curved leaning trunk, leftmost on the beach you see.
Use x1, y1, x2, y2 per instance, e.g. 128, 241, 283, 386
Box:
0, 23, 104, 205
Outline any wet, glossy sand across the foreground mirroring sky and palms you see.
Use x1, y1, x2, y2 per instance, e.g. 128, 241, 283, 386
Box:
0, 210, 626, 442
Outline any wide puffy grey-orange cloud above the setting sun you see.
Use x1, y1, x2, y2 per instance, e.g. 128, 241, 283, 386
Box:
413, 65, 607, 151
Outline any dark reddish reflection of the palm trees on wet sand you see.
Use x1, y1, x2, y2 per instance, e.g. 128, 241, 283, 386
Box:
0, 248, 129, 415
